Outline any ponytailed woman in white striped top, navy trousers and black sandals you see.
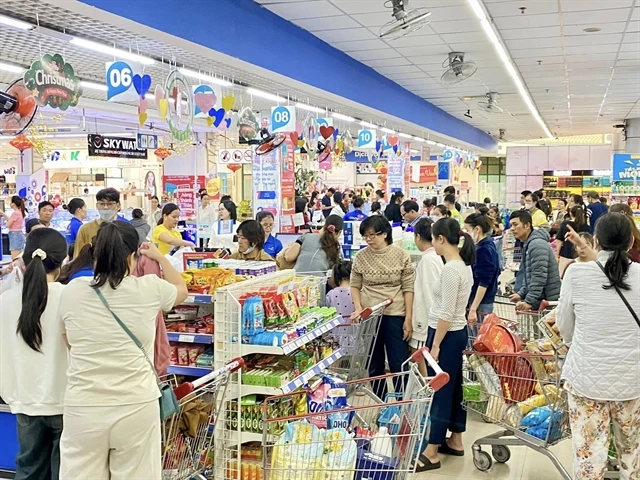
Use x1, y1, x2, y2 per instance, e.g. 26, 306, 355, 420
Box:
416, 218, 475, 472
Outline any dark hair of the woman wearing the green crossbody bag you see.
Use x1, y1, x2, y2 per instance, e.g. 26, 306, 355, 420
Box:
93, 220, 140, 289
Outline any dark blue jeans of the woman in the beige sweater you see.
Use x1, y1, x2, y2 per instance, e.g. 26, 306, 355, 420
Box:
369, 315, 409, 400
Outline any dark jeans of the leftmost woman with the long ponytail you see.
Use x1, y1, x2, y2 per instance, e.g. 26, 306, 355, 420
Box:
15, 414, 62, 480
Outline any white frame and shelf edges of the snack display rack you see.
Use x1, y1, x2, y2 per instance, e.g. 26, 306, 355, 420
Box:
213, 270, 344, 479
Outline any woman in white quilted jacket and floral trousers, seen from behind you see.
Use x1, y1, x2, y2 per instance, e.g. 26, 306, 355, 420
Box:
556, 213, 640, 480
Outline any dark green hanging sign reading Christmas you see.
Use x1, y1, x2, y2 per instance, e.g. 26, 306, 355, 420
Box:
23, 53, 82, 110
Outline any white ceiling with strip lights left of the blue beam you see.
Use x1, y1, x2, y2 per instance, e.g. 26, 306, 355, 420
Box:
0, 0, 490, 155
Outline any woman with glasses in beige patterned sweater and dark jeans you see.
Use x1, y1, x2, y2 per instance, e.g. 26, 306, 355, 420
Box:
351, 216, 414, 399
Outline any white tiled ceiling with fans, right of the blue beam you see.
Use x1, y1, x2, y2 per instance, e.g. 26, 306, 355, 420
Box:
255, 0, 640, 140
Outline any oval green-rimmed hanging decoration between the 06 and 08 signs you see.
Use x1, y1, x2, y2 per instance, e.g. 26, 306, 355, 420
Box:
164, 70, 194, 141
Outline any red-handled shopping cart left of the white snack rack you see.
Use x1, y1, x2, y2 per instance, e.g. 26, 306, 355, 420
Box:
162, 358, 244, 480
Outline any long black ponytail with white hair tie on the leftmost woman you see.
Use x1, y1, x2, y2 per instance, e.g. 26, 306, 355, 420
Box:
16, 228, 67, 352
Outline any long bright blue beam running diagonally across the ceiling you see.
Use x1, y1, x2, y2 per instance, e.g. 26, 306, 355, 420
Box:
80, 0, 498, 151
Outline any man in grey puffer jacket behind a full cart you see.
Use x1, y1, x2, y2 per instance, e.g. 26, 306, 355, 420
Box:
510, 210, 560, 310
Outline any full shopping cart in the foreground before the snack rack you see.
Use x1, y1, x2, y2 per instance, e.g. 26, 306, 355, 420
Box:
260, 348, 449, 480
